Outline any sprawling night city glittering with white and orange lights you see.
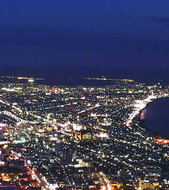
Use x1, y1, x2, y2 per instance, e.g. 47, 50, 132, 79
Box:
0, 77, 169, 190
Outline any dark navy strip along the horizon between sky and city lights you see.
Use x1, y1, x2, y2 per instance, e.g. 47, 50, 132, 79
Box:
0, 66, 169, 85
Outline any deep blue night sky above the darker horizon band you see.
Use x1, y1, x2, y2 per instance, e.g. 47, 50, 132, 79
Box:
0, 0, 169, 68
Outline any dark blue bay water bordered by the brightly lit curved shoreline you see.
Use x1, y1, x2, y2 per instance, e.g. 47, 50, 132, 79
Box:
144, 98, 169, 138
